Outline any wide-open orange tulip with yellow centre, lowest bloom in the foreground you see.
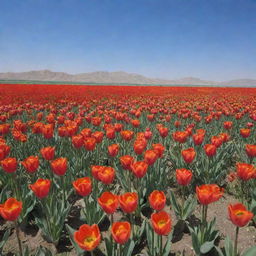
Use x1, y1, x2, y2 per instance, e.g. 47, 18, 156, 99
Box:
74, 224, 101, 251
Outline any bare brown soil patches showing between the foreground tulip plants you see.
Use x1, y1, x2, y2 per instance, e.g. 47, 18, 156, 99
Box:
0, 195, 256, 256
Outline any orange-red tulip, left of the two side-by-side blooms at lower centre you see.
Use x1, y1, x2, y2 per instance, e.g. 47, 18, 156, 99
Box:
98, 192, 118, 214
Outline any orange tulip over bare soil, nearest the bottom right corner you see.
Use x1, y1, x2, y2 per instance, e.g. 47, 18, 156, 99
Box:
228, 203, 253, 227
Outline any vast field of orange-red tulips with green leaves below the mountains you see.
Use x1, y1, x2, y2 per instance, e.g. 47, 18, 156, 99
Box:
0, 84, 256, 256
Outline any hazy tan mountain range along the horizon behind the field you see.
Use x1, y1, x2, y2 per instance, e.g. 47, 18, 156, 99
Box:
0, 70, 256, 86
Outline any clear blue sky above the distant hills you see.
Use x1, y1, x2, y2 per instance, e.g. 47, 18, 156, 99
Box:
0, 0, 256, 81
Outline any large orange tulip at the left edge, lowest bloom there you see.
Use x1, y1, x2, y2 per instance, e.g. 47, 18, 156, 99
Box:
0, 197, 22, 221
